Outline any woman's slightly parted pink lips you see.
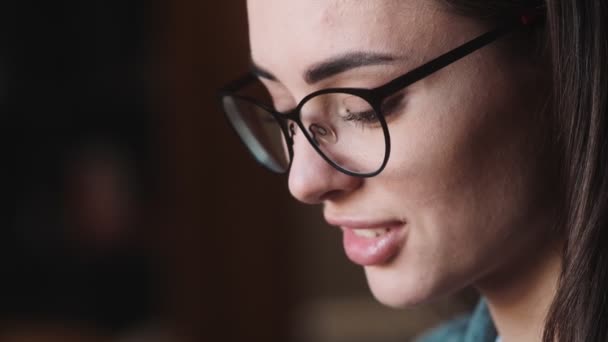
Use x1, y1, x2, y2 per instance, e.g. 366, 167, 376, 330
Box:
334, 223, 405, 266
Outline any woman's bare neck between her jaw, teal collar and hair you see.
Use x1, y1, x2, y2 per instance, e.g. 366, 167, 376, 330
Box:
477, 240, 562, 342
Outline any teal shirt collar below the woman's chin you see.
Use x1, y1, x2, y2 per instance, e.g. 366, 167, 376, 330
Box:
416, 300, 497, 342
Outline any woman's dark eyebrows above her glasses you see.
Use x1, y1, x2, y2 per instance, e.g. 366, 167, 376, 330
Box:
251, 51, 398, 85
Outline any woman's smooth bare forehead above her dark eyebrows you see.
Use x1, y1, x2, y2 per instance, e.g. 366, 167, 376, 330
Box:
248, 0, 445, 82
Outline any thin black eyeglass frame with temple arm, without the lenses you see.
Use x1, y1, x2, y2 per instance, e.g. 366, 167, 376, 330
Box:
218, 20, 526, 178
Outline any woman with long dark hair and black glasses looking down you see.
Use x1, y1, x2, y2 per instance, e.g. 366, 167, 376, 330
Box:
222, 0, 608, 342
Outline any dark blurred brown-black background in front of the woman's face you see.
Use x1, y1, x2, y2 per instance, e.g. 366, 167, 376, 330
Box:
0, 0, 474, 342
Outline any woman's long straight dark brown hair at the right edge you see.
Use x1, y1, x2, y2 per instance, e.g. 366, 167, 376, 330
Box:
443, 0, 608, 342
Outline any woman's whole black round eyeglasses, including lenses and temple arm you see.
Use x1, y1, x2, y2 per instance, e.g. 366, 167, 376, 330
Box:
219, 22, 522, 177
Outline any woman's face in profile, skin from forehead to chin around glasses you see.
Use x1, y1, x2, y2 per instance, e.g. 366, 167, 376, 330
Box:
248, 0, 551, 306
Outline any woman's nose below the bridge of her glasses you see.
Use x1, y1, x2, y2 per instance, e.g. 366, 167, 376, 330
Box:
289, 132, 363, 204
